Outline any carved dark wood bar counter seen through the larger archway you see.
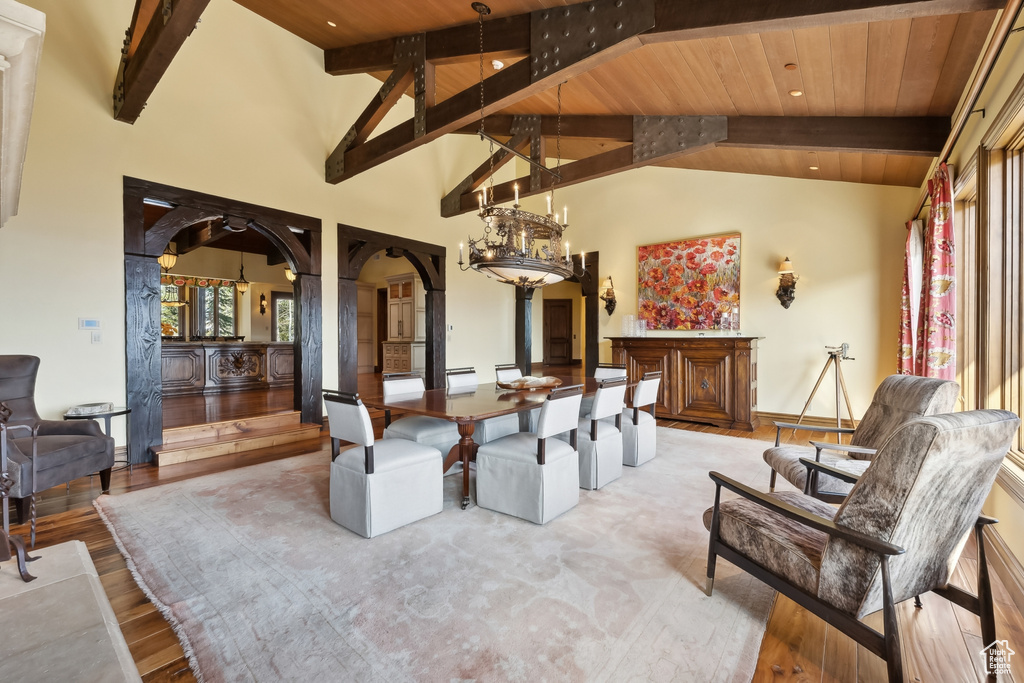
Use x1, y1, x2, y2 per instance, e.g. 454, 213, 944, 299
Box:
161, 340, 295, 396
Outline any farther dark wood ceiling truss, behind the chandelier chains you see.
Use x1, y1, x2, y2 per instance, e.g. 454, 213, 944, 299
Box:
441, 115, 949, 217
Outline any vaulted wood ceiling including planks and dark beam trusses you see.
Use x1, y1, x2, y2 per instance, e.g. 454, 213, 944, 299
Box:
115, 0, 1006, 208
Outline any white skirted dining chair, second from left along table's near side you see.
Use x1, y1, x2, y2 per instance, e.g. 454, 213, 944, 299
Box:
476, 385, 583, 524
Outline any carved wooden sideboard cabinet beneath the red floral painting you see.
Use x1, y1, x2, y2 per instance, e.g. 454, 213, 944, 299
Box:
608, 337, 761, 431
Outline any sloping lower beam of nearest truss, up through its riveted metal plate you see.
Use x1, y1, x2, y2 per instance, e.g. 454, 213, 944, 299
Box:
325, 0, 654, 183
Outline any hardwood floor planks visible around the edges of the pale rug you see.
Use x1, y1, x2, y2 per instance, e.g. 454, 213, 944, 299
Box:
3, 369, 1024, 683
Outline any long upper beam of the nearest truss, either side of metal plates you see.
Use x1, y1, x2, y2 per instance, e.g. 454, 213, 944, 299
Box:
324, 0, 1006, 76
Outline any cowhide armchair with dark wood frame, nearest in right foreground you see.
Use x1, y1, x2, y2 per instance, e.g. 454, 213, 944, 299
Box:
705, 411, 1020, 681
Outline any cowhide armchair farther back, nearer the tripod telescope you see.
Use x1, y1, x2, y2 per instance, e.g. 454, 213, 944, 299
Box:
764, 375, 959, 503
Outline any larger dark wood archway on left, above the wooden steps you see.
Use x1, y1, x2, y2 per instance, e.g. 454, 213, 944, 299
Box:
124, 176, 324, 462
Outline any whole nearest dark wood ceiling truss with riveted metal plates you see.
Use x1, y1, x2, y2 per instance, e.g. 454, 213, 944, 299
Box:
324, 0, 991, 187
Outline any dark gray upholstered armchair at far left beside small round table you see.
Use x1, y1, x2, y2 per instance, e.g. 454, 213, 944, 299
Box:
0, 355, 114, 545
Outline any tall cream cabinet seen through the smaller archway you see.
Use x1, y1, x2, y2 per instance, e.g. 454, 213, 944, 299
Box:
384, 273, 427, 373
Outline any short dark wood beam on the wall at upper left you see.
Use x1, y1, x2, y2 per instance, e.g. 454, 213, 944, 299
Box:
114, 0, 210, 123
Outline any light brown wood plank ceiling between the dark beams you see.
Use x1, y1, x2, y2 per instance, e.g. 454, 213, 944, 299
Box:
236, 0, 999, 191
